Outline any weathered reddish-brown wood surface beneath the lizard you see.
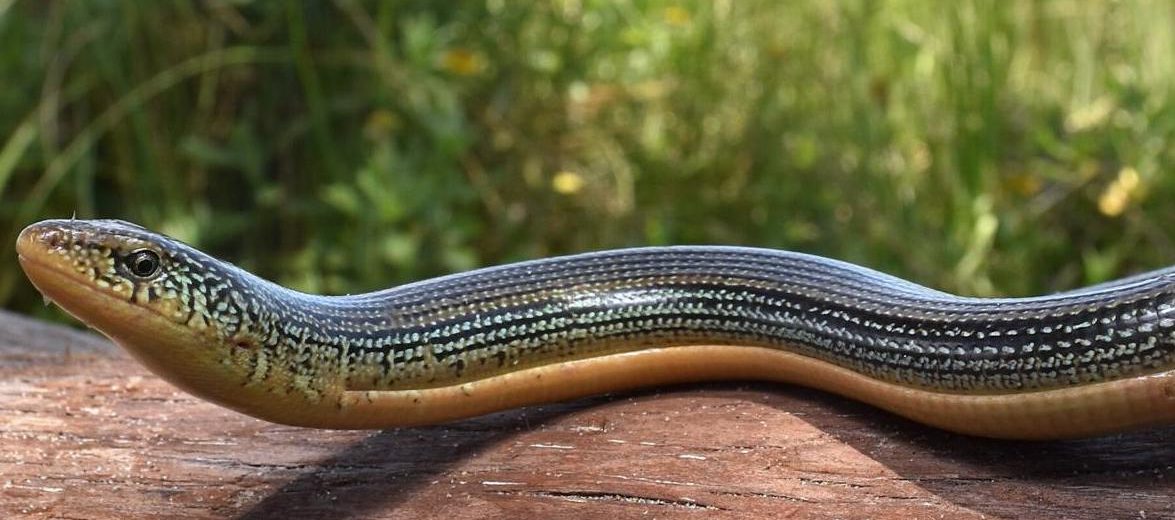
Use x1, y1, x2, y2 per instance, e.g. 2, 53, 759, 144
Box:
0, 312, 1175, 519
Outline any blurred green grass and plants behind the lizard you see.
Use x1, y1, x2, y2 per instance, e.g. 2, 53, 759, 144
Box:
0, 0, 1175, 323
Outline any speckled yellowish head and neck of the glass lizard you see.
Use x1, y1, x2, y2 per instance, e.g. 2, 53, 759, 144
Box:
16, 220, 326, 420
